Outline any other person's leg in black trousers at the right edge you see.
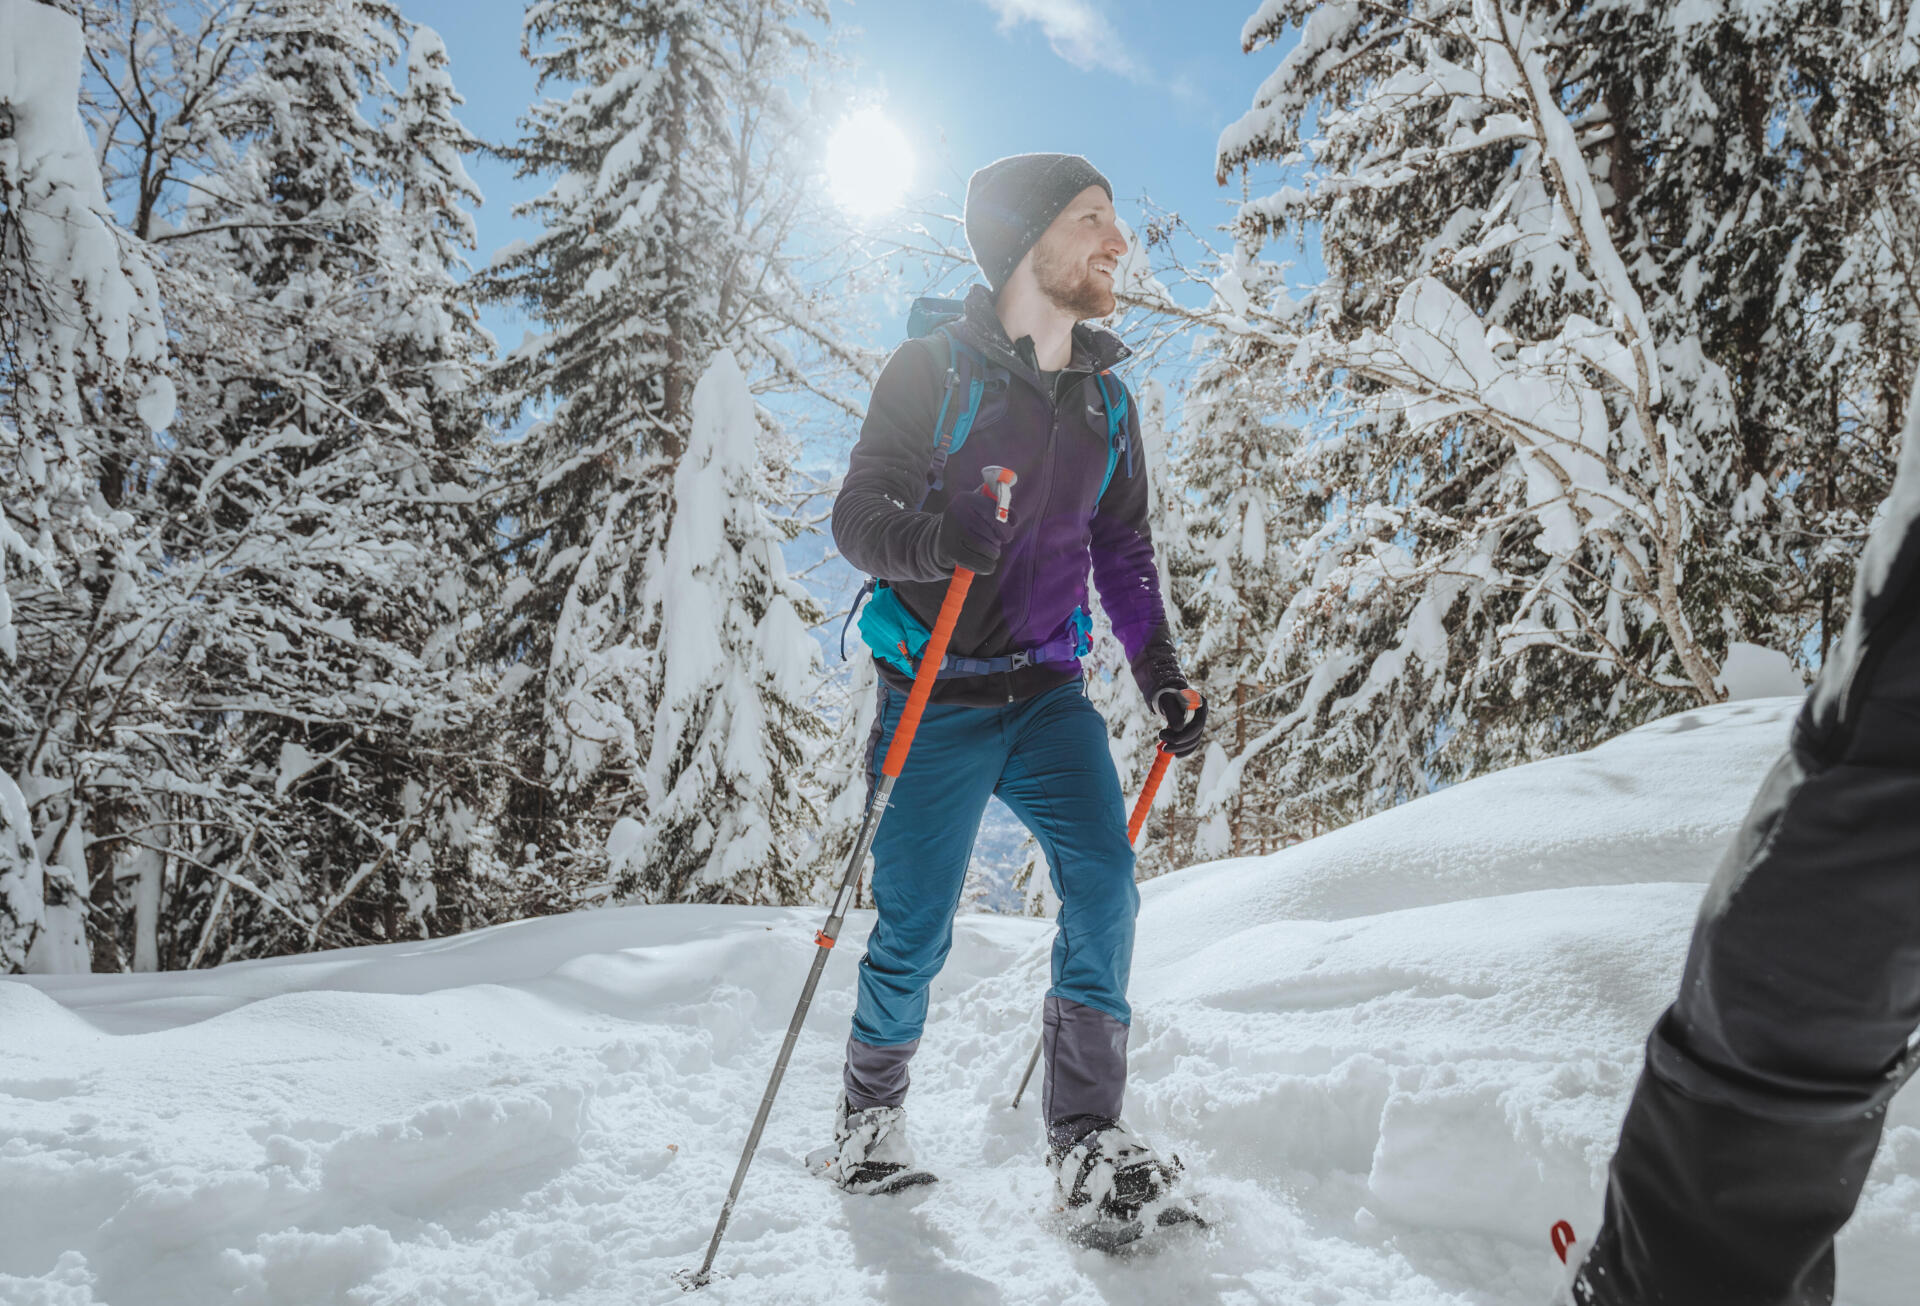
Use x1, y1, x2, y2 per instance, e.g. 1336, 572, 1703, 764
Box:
1572, 378, 1920, 1306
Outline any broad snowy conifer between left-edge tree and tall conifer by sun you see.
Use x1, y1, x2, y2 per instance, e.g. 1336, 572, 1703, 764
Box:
144, 0, 488, 951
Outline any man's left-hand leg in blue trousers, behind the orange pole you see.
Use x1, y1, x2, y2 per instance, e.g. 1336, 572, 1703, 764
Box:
843, 686, 1006, 1110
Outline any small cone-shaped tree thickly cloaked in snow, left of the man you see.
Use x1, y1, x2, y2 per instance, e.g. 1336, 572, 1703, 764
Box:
606, 350, 826, 903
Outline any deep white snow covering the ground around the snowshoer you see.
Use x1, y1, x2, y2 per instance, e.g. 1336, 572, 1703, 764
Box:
0, 699, 1920, 1306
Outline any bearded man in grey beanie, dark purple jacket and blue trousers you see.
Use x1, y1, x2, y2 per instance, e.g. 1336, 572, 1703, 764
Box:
829, 154, 1206, 1218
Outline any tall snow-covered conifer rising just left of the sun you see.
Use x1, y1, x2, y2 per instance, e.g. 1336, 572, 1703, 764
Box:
484, 0, 858, 897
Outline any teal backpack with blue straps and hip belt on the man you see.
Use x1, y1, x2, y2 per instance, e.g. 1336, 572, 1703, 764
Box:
841, 296, 1133, 680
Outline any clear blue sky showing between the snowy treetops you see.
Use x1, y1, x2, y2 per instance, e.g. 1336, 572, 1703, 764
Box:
403, 0, 1305, 336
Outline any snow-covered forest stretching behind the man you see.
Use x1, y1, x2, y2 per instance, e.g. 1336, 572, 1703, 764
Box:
0, 0, 1920, 972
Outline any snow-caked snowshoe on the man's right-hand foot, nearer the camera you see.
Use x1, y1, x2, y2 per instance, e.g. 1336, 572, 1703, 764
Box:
1046, 1120, 1206, 1252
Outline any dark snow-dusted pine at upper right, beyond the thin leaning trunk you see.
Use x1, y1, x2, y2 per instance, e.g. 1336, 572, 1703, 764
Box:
1565, 0, 1920, 665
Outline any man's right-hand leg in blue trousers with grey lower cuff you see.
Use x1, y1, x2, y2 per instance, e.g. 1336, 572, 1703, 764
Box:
998, 684, 1140, 1141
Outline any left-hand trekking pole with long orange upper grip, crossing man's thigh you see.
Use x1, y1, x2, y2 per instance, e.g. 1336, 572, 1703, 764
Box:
674, 467, 1018, 1293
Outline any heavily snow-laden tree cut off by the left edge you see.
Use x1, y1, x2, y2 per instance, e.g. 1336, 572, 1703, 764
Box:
0, 0, 175, 970
